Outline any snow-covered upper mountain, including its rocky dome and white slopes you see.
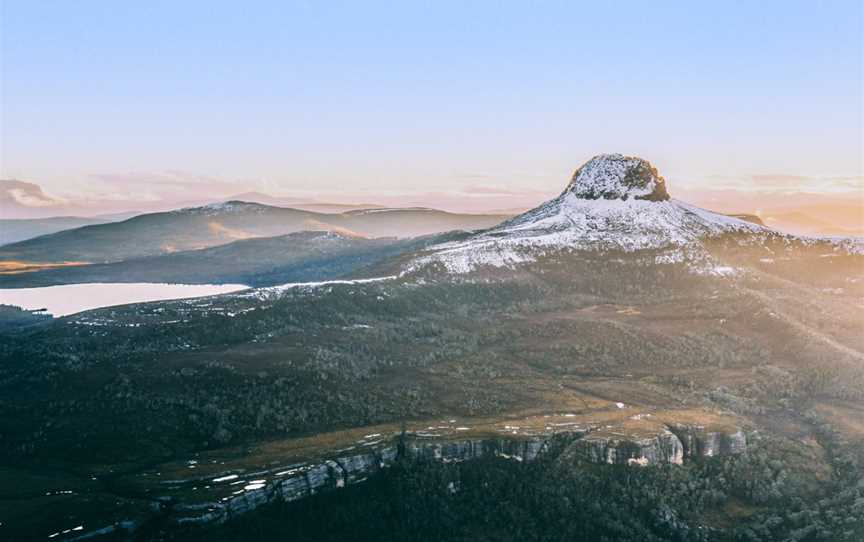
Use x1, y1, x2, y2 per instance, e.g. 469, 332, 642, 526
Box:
407, 154, 774, 273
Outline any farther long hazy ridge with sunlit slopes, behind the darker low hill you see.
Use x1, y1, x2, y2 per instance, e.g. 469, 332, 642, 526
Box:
0, 201, 505, 263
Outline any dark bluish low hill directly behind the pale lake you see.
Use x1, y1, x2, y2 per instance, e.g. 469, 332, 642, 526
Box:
0, 232, 455, 288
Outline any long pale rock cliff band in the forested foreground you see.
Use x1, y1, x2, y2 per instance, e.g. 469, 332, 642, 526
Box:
163, 426, 747, 524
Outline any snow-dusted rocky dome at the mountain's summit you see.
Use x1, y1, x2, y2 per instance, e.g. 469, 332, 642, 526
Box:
567, 154, 669, 201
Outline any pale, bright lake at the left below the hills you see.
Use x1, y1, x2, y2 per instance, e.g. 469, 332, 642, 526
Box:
0, 282, 249, 317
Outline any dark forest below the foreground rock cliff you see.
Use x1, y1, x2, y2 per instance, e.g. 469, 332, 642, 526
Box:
165, 428, 864, 542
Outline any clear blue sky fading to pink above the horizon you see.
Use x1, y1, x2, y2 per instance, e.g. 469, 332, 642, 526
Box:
0, 0, 864, 221
